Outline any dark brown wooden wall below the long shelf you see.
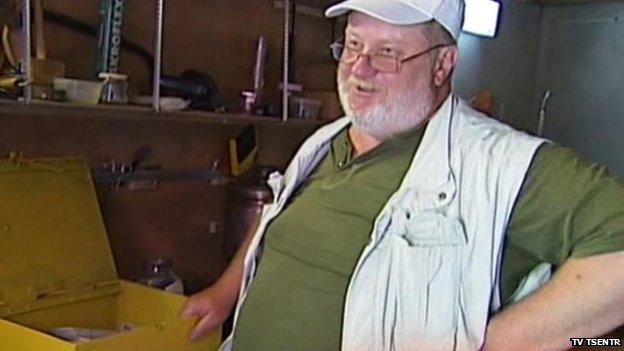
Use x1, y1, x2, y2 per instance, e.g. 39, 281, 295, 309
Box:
0, 104, 317, 292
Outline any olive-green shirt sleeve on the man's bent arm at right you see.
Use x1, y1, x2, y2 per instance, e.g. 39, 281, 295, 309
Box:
501, 144, 624, 303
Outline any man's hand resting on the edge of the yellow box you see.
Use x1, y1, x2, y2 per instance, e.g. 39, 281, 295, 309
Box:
181, 284, 236, 340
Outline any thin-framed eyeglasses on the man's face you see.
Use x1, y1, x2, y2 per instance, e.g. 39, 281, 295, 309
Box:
329, 42, 448, 73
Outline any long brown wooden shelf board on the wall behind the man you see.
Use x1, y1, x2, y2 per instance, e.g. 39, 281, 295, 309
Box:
0, 100, 327, 128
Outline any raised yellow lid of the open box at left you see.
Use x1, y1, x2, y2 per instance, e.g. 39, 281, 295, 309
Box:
0, 158, 117, 317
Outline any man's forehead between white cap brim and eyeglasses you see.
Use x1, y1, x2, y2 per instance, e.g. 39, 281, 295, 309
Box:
345, 11, 427, 43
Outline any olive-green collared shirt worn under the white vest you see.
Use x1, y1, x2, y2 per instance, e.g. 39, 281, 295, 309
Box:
234, 125, 624, 351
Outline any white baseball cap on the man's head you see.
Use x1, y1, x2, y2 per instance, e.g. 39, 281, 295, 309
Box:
325, 0, 464, 41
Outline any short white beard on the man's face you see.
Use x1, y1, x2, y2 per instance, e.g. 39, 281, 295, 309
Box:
338, 78, 434, 141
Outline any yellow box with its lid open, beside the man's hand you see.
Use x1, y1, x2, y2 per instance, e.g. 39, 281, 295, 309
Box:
0, 158, 220, 351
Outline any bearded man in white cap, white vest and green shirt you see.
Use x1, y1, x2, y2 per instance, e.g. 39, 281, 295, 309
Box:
183, 0, 624, 351
